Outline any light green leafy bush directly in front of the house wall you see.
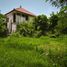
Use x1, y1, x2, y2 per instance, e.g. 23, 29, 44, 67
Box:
17, 22, 34, 36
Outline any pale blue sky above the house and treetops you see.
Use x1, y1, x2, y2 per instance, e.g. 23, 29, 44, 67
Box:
0, 0, 59, 17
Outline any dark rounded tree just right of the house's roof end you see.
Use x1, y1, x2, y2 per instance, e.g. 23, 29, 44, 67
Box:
34, 15, 48, 35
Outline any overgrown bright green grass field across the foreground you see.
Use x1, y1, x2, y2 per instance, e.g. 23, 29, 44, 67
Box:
0, 36, 67, 67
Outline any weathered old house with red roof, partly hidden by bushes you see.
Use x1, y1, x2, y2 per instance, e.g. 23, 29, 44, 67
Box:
5, 7, 35, 33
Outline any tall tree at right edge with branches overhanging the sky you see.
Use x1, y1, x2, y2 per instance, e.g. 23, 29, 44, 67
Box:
45, 0, 67, 34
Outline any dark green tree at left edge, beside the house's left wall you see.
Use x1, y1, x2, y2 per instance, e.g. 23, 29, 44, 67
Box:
0, 14, 7, 36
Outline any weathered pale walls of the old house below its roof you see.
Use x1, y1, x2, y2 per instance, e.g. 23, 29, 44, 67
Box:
6, 11, 33, 33
